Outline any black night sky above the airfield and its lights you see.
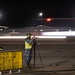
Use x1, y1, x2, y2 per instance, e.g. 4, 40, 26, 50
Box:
0, 0, 75, 28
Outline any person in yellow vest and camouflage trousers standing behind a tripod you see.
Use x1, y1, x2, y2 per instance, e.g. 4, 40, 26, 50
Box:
24, 33, 33, 67
